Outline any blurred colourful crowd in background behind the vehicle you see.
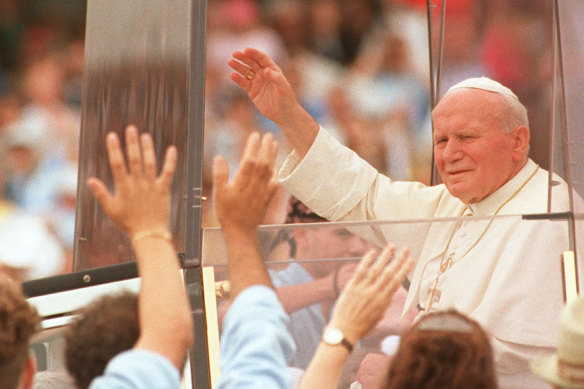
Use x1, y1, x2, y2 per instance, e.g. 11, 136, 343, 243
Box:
0, 0, 551, 279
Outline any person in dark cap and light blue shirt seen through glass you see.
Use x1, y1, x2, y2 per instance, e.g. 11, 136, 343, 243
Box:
269, 197, 369, 369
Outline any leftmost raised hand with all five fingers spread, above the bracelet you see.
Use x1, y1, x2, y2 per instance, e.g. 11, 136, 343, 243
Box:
87, 125, 177, 238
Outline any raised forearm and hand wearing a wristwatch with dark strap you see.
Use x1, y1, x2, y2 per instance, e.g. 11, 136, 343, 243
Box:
300, 245, 413, 389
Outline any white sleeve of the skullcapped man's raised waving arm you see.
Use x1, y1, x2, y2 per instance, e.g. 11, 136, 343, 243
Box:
279, 128, 448, 221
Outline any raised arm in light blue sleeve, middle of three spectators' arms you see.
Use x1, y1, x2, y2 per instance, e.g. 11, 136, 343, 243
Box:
213, 133, 294, 389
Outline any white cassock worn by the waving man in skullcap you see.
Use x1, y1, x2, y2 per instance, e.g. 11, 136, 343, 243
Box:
279, 129, 569, 388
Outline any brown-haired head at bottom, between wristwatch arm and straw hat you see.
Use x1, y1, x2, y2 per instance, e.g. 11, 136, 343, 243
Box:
383, 311, 497, 389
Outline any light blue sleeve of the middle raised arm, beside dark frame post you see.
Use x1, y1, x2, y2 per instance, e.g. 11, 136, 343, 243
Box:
217, 285, 295, 389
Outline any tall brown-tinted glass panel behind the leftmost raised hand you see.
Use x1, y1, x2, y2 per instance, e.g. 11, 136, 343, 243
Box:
75, 0, 190, 270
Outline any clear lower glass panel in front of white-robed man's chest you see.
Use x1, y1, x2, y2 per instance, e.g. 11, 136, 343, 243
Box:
203, 214, 569, 378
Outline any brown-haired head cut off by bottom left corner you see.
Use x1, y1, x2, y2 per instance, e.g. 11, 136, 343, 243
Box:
0, 275, 40, 389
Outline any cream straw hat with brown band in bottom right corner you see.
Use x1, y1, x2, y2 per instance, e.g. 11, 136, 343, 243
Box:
530, 297, 584, 389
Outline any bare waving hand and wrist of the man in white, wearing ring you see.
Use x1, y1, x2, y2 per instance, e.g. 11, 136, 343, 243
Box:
228, 48, 319, 157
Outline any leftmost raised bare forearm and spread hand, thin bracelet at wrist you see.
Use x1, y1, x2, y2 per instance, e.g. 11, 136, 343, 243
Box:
87, 126, 193, 369
